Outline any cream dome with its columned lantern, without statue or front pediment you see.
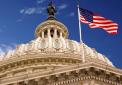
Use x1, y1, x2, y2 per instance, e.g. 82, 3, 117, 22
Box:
0, 2, 113, 75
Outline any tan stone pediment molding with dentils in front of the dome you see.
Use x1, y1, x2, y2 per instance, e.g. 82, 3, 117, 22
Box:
1, 63, 122, 85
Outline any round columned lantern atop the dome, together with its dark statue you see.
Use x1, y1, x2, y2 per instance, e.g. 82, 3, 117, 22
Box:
35, 2, 68, 38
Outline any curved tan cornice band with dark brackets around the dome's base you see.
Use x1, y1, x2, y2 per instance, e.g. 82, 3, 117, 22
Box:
0, 57, 81, 74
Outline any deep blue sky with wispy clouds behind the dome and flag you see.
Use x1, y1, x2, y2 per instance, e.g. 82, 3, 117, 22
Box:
0, 0, 122, 68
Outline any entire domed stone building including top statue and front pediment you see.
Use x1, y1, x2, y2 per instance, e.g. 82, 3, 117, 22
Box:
0, 3, 122, 85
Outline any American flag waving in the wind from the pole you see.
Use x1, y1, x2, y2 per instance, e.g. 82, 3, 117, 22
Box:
79, 8, 118, 34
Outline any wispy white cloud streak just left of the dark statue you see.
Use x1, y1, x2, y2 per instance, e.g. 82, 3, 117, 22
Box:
19, 7, 46, 15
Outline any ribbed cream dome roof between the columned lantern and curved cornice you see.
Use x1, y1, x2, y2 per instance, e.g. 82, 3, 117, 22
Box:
2, 37, 113, 66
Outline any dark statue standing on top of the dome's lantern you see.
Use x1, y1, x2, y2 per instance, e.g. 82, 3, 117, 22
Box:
47, 1, 56, 19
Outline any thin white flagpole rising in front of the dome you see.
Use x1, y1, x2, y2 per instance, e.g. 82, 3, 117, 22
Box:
77, 5, 85, 63
